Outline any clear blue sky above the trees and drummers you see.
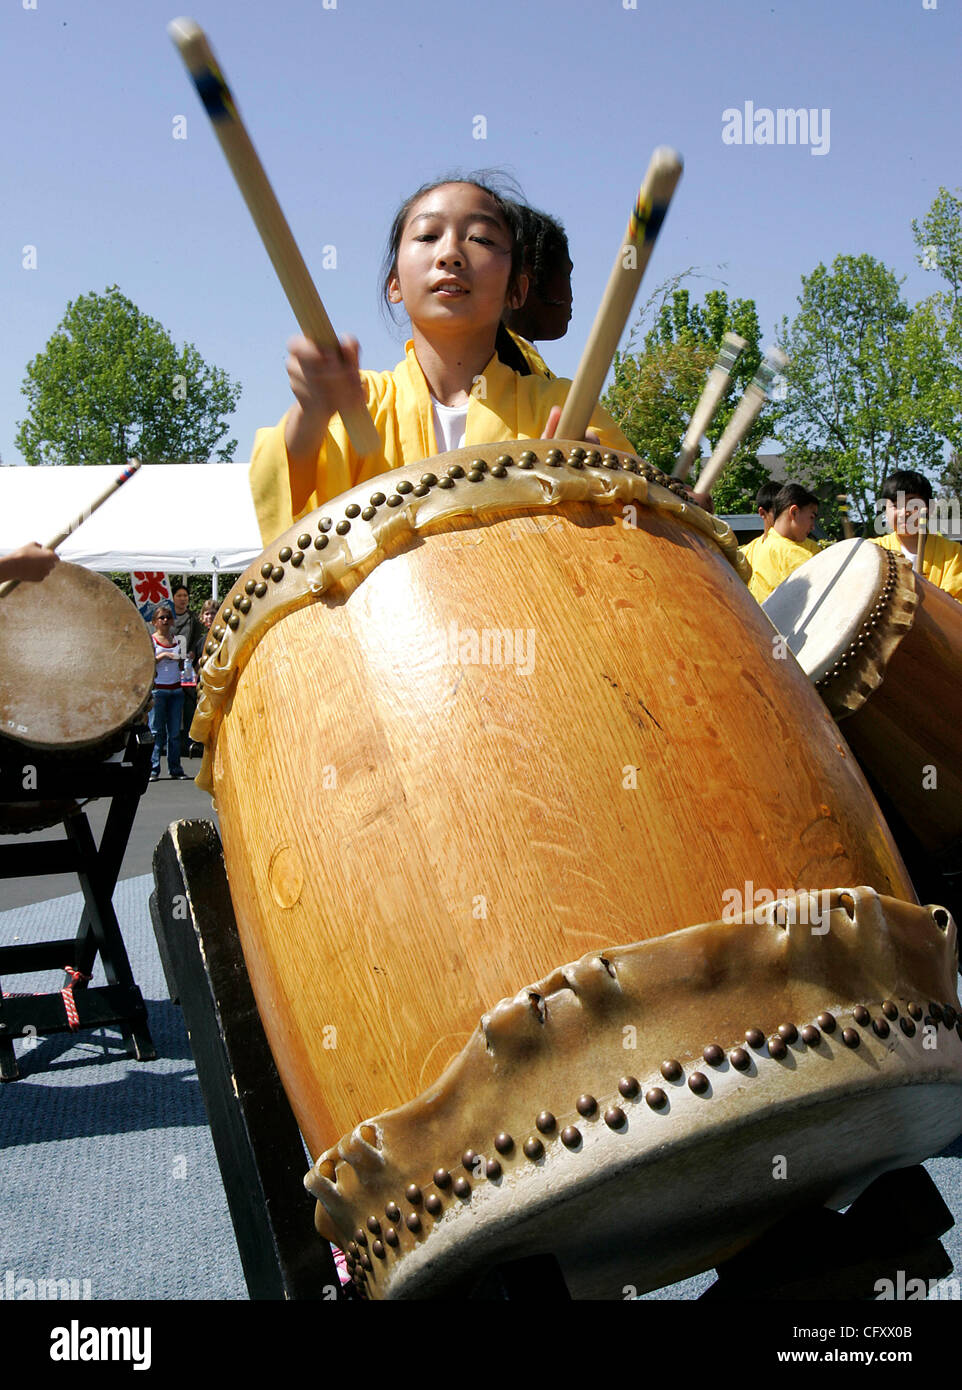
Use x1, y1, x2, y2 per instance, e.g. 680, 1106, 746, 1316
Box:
0, 0, 962, 463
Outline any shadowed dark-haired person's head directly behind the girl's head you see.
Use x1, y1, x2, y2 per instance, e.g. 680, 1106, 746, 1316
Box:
503, 203, 574, 381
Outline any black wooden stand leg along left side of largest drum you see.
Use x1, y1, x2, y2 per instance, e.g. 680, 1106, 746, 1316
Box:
150, 820, 346, 1300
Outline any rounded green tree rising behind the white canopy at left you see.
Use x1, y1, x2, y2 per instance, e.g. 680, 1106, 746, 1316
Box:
17, 285, 241, 464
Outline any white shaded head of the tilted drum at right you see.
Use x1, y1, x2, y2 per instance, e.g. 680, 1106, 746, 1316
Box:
762, 539, 887, 684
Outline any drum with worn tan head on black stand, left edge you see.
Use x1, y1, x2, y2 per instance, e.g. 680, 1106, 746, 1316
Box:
0, 562, 154, 833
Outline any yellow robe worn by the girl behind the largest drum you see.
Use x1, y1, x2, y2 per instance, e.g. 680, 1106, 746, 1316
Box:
250, 342, 634, 545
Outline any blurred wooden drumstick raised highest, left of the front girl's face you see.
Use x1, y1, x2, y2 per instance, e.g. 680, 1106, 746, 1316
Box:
167, 19, 381, 455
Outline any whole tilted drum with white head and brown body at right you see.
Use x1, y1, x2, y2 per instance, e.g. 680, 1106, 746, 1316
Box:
765, 539, 962, 865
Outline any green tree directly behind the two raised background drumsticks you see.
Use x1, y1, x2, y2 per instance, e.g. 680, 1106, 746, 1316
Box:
602, 279, 772, 512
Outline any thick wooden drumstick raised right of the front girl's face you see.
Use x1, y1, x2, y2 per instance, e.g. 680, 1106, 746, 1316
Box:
555, 146, 681, 439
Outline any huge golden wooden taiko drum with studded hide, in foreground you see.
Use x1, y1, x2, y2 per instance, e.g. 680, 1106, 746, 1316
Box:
193, 441, 962, 1298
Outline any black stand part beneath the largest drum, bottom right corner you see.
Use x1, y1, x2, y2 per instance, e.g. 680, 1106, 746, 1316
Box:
702, 1168, 954, 1301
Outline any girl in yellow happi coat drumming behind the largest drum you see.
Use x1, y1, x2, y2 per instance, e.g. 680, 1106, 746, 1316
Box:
250, 182, 633, 545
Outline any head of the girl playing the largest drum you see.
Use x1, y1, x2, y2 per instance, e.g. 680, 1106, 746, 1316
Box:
388, 183, 527, 340
